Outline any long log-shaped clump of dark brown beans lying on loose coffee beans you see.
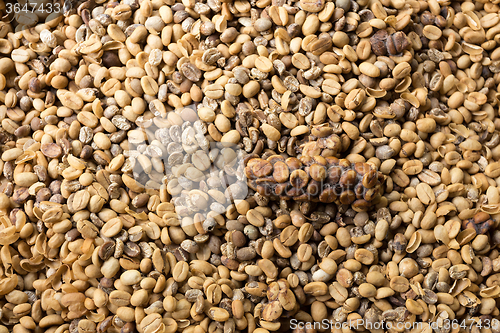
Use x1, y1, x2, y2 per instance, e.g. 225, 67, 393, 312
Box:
245, 155, 384, 211
